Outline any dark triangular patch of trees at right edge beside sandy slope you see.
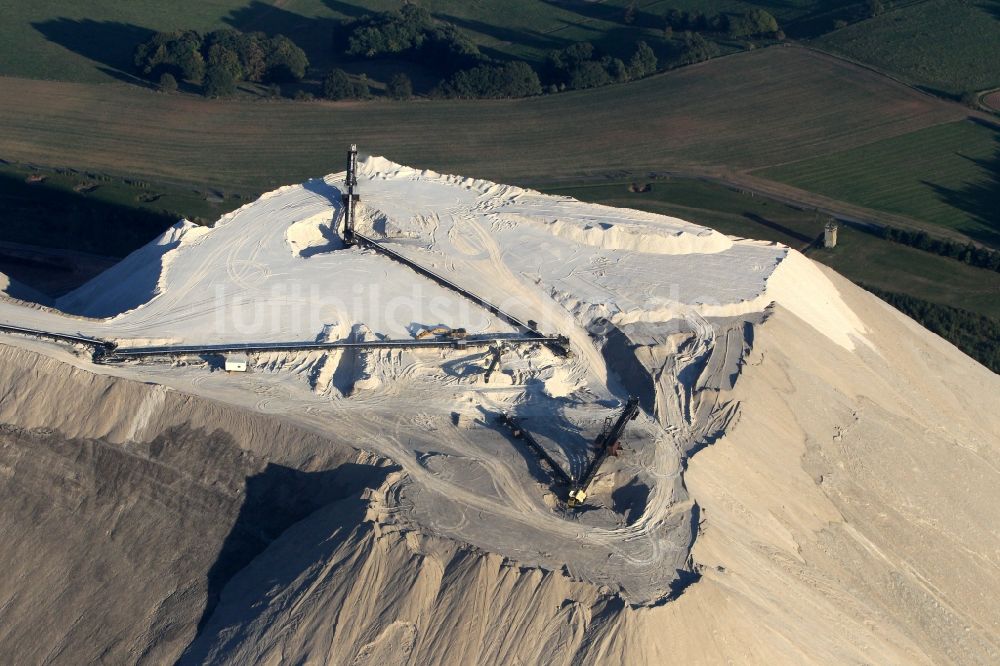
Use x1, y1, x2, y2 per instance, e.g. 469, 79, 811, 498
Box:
861, 285, 1000, 373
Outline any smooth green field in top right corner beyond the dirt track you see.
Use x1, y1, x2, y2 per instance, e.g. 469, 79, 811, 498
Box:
817, 0, 1000, 97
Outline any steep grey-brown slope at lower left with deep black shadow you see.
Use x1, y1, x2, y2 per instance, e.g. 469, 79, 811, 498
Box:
0, 347, 388, 664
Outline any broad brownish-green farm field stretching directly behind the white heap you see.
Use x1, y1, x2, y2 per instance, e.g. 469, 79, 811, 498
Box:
0, 48, 963, 192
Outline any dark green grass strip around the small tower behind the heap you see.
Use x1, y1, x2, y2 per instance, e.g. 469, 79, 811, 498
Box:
540, 178, 1000, 319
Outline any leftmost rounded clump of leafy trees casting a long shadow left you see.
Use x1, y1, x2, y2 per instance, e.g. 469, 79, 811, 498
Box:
135, 30, 309, 97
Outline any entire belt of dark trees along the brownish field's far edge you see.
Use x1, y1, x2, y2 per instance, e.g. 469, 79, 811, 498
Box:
135, 2, 780, 100
